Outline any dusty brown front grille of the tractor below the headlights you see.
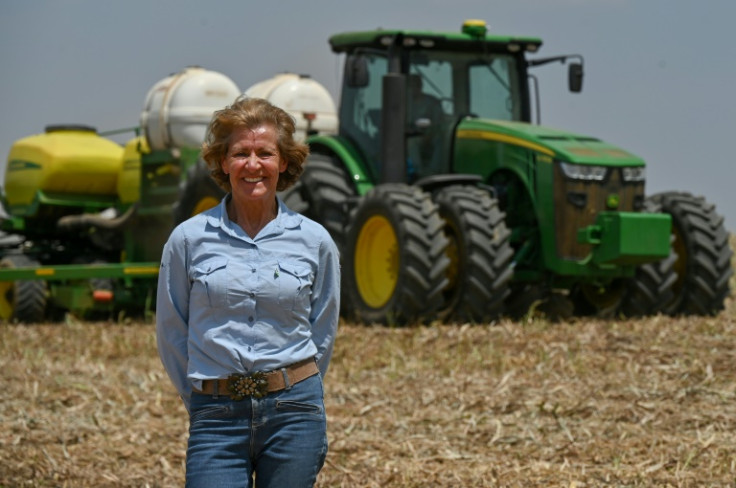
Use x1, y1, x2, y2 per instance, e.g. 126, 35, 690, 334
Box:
554, 164, 644, 260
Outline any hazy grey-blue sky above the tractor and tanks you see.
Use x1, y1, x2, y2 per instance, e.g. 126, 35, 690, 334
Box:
0, 0, 736, 231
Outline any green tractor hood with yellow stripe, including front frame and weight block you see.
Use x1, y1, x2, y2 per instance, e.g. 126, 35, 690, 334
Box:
452, 119, 656, 285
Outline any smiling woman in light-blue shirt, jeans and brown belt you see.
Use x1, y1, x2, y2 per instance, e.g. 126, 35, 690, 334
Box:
156, 98, 340, 487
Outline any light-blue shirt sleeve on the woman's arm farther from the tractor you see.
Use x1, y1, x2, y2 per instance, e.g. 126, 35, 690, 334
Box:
156, 227, 192, 411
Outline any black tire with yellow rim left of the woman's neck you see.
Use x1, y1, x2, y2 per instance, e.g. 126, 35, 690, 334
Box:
174, 159, 225, 225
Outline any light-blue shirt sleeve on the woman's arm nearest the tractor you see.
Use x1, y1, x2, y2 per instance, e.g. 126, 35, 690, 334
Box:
309, 234, 340, 377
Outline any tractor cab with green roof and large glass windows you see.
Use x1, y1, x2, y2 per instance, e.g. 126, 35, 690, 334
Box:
330, 21, 541, 183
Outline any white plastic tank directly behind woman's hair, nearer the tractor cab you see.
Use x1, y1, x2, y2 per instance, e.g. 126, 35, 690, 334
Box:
245, 73, 338, 141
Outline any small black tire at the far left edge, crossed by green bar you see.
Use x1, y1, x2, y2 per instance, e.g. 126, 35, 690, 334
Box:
0, 254, 48, 323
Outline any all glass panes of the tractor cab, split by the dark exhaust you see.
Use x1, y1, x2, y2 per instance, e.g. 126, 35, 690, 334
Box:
340, 49, 526, 182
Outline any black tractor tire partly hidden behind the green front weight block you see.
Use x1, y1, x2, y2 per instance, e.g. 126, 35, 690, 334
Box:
619, 198, 677, 317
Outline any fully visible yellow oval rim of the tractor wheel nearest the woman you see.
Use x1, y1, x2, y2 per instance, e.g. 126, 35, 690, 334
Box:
354, 216, 399, 308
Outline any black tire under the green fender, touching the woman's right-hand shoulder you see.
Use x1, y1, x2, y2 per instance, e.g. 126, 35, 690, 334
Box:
281, 153, 355, 251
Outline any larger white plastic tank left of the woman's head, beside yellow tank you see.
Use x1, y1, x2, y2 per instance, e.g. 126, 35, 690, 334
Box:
141, 66, 241, 150
